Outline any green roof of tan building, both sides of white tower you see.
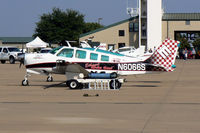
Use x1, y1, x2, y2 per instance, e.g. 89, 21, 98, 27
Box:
80, 13, 200, 38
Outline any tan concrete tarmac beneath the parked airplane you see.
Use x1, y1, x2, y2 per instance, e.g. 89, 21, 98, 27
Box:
0, 60, 200, 133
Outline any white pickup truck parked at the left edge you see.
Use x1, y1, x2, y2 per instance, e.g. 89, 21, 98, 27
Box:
0, 46, 23, 64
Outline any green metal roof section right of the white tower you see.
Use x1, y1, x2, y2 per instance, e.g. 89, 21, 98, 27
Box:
162, 13, 200, 21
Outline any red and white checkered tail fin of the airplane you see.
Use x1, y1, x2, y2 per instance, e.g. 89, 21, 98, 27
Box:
150, 39, 180, 71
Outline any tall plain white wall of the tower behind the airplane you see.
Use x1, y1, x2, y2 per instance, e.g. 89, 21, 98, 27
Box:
147, 0, 162, 49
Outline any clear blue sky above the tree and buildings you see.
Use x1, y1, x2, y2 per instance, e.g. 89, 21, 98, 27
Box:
0, 0, 200, 37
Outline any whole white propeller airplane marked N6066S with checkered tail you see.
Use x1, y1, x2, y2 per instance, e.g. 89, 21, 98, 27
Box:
22, 39, 180, 89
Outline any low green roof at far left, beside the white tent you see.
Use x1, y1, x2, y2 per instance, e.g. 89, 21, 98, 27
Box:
0, 37, 34, 44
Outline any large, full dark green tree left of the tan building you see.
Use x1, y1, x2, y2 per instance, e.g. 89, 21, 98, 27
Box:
33, 8, 85, 43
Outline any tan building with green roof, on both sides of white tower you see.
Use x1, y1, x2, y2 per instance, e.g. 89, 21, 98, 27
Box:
79, 13, 200, 49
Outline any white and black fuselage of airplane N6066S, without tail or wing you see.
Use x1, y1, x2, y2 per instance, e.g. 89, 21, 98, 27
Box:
25, 47, 153, 75
